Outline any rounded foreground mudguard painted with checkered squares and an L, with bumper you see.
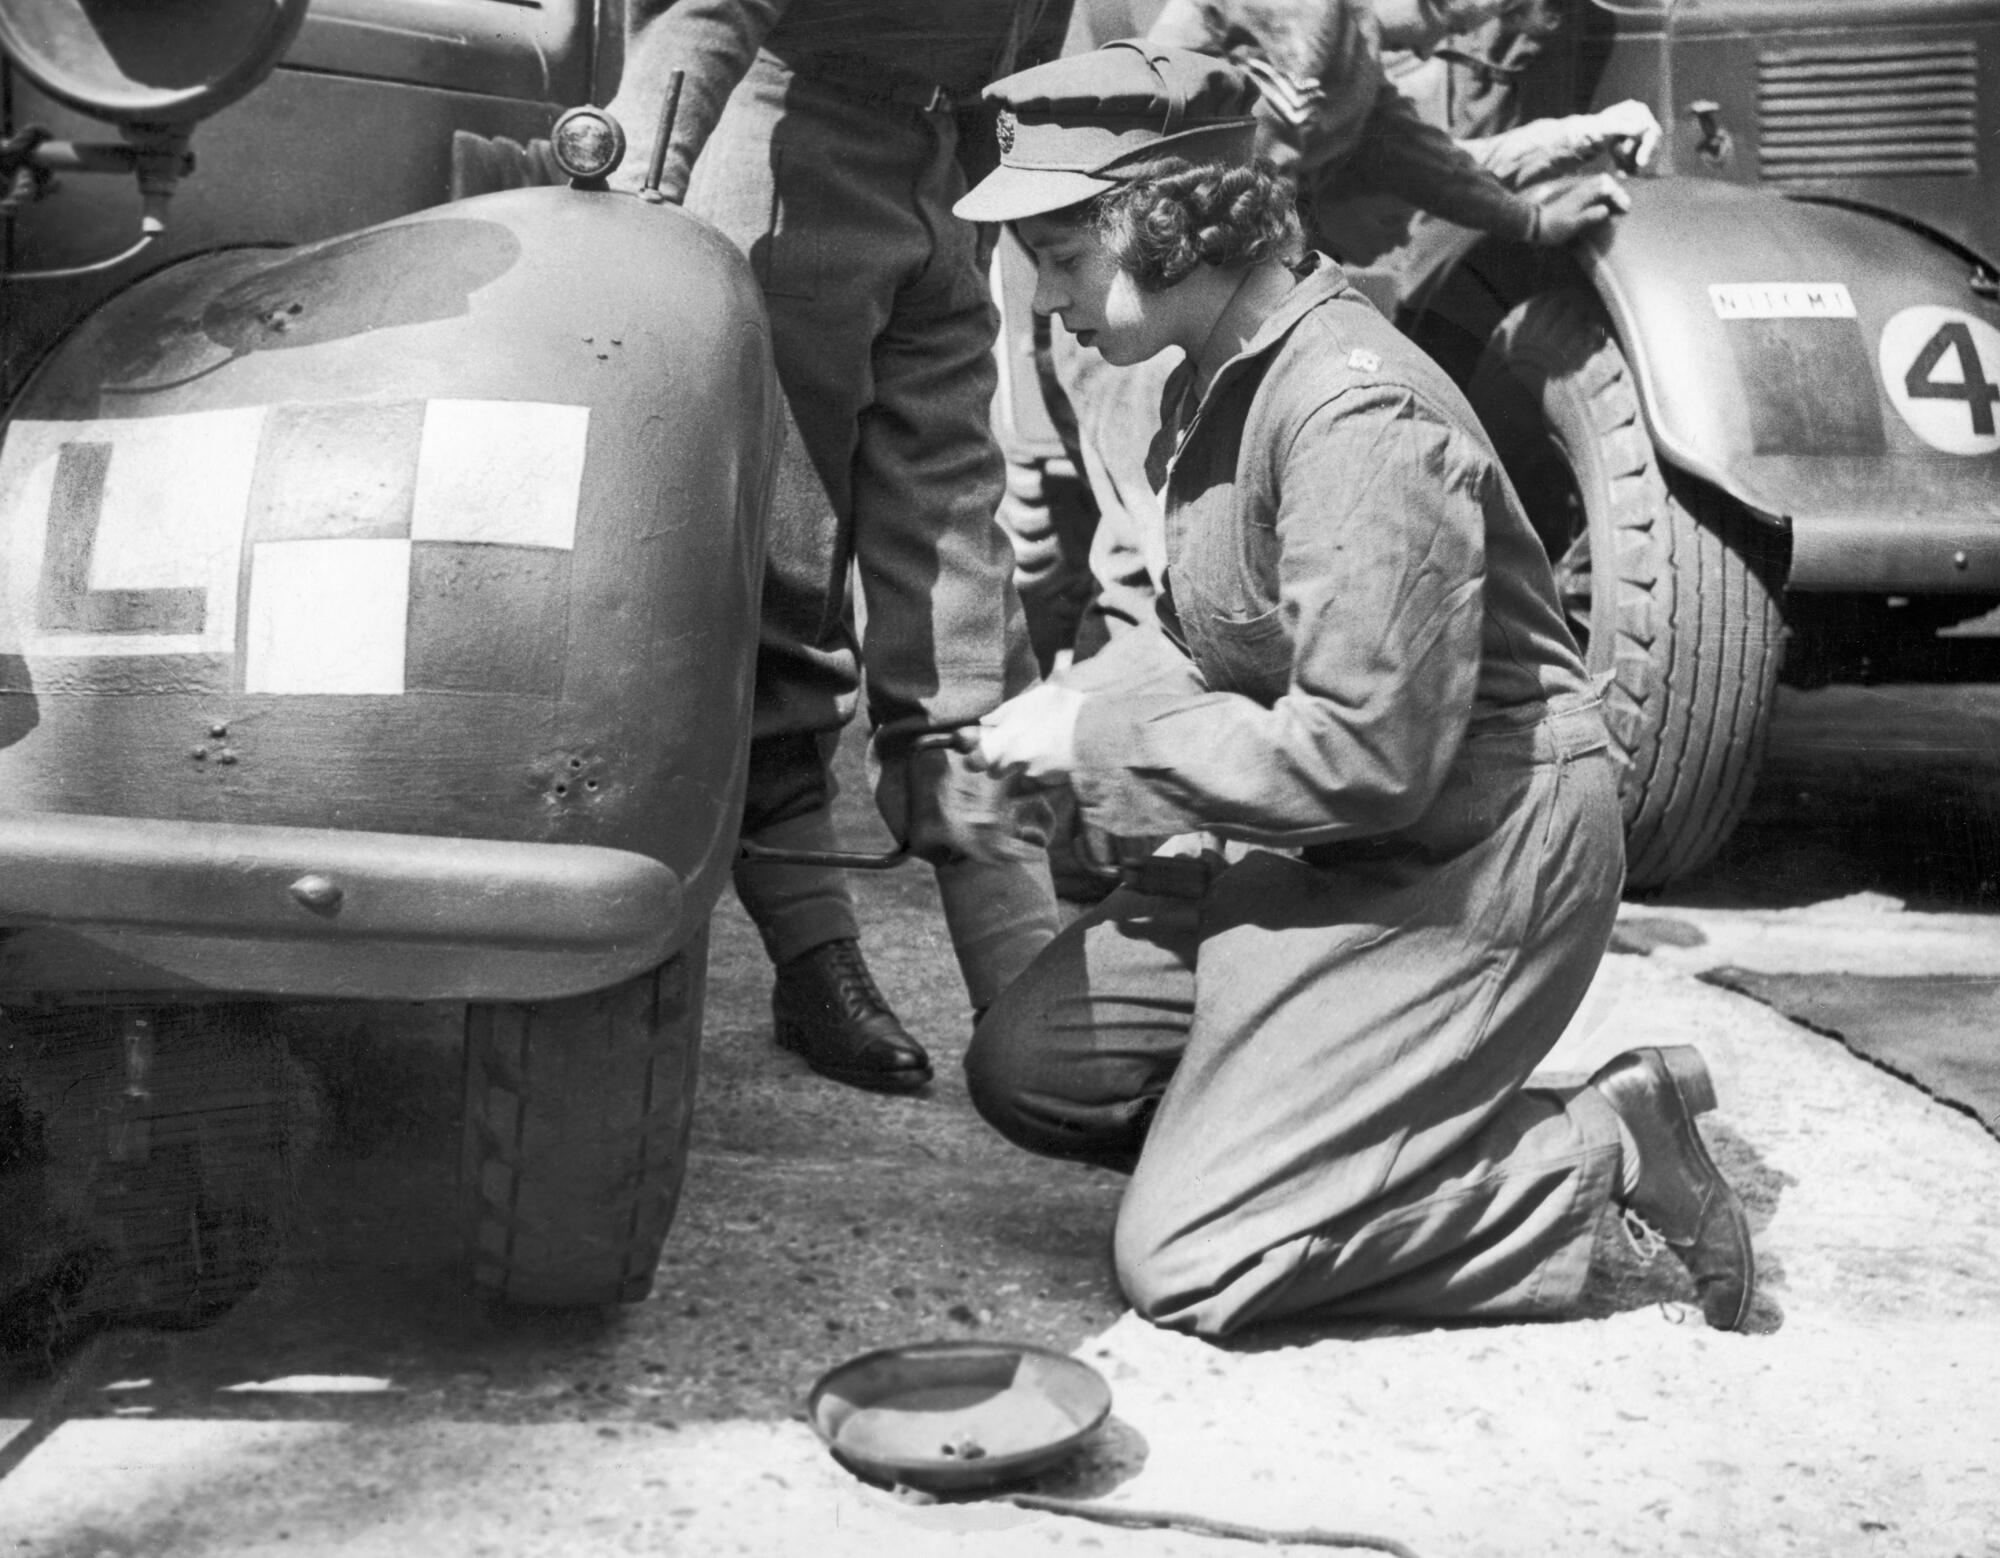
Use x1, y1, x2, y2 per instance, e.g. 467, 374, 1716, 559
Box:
0, 188, 782, 998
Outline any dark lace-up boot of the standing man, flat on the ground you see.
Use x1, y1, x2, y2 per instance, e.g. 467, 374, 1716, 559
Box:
770, 940, 930, 1092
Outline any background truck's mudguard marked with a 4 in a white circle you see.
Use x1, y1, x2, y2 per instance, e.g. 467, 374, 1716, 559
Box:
1578, 178, 2000, 592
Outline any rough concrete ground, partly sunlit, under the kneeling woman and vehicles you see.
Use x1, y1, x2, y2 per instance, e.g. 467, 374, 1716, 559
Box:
0, 688, 2000, 1558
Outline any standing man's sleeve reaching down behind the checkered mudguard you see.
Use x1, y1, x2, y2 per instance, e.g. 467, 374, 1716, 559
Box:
610, 0, 792, 200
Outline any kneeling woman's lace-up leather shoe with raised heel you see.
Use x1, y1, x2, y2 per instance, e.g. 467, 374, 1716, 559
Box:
1590, 1044, 1756, 1330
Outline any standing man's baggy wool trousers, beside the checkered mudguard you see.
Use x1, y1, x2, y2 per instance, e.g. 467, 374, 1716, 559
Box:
688, 54, 1054, 1004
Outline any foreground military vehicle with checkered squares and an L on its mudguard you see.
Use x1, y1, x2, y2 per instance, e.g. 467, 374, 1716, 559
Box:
0, 0, 782, 1322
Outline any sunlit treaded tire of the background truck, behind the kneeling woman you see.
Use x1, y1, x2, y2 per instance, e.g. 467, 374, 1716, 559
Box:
1468, 288, 1784, 888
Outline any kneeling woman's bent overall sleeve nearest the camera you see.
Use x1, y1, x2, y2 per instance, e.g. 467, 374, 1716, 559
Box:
1072, 384, 1498, 846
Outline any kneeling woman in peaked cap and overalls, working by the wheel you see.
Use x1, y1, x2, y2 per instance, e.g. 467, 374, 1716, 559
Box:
958, 44, 1754, 1336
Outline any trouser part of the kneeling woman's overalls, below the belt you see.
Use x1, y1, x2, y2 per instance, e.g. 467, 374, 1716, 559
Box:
966, 700, 1624, 1336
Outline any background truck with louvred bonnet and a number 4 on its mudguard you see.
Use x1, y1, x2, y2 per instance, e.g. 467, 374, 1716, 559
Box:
1398, 0, 2000, 888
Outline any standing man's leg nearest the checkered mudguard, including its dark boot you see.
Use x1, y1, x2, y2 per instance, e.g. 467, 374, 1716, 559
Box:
688, 58, 930, 1092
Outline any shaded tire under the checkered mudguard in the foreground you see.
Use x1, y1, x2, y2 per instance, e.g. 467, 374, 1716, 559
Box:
458, 926, 708, 1308
